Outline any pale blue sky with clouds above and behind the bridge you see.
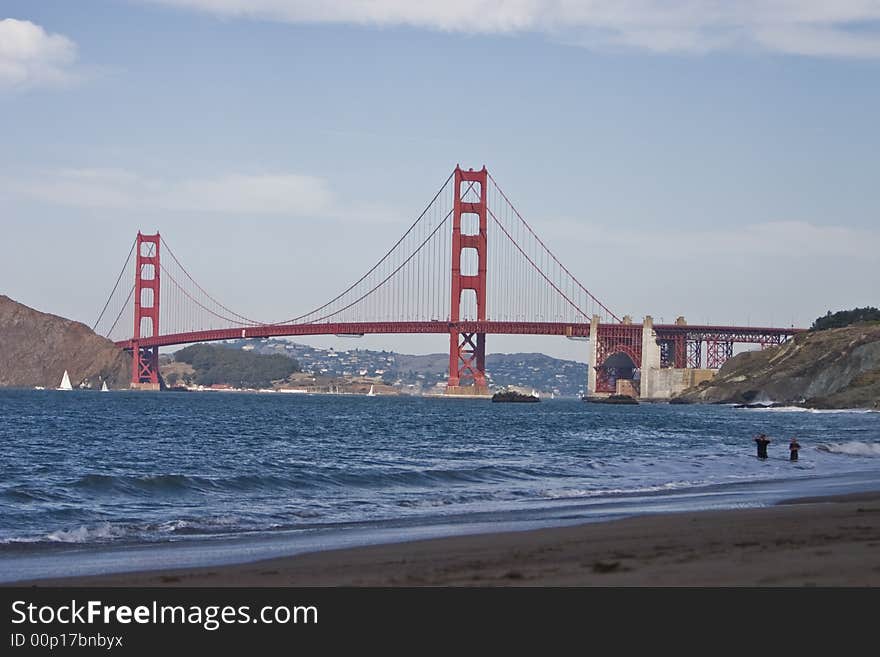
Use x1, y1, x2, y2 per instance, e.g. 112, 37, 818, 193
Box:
0, 0, 880, 359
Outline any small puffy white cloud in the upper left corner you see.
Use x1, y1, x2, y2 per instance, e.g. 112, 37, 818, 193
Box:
0, 18, 77, 89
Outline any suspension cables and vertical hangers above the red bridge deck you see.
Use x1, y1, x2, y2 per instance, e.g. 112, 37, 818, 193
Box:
94, 164, 620, 341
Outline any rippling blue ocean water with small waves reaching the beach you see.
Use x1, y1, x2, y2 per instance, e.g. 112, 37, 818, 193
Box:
0, 390, 880, 581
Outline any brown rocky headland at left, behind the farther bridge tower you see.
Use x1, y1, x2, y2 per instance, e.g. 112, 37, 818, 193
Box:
0, 295, 131, 388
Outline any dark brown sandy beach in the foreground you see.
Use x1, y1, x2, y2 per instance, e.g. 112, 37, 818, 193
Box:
16, 492, 880, 586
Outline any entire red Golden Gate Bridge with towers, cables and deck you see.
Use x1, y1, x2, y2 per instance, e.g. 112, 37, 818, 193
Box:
94, 166, 800, 396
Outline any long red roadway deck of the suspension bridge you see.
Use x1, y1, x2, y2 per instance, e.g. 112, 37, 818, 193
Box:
116, 321, 804, 349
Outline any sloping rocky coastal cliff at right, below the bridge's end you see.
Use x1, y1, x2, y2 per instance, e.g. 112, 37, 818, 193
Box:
675, 322, 880, 409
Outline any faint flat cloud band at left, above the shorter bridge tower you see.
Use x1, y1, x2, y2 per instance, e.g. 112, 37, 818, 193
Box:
0, 169, 335, 216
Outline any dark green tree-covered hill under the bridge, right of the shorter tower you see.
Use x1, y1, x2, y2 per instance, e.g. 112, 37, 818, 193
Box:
174, 344, 299, 388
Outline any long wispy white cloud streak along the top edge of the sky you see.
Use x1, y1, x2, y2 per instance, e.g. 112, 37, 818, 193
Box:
142, 0, 880, 58
